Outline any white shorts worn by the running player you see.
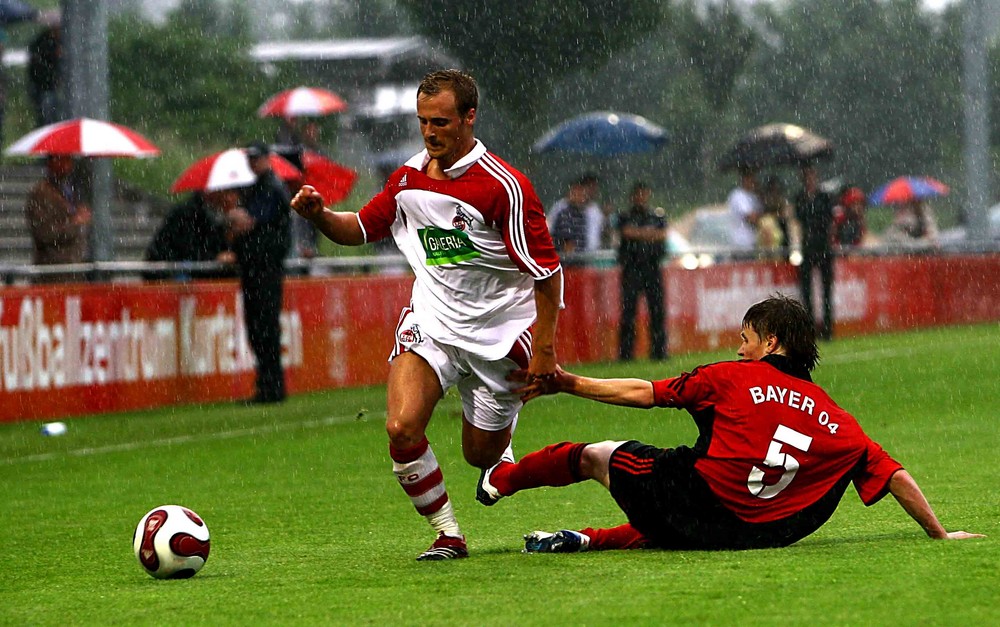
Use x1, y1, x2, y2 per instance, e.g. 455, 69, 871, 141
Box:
389, 307, 531, 431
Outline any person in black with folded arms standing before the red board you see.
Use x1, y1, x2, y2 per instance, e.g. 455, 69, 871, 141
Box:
618, 182, 667, 361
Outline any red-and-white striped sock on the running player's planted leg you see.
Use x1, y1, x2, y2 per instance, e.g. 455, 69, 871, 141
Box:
389, 438, 462, 537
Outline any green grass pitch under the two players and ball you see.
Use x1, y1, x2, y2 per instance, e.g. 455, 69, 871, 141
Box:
0, 324, 1000, 625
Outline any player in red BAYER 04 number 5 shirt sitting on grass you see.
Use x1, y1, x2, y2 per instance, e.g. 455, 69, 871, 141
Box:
477, 295, 982, 552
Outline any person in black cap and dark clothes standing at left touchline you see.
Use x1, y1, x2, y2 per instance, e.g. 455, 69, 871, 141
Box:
230, 142, 291, 404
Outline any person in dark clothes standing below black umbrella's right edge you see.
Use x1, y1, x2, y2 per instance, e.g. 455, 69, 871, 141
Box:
795, 163, 835, 340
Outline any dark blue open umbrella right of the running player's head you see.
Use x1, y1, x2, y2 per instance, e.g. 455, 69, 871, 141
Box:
532, 111, 667, 157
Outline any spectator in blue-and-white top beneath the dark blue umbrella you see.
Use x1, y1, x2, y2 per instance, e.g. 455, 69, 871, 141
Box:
547, 175, 604, 253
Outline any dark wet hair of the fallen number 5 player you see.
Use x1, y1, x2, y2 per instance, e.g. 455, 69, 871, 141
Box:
743, 294, 819, 371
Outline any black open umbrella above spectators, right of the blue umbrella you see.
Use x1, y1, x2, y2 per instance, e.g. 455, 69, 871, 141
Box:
718, 124, 833, 170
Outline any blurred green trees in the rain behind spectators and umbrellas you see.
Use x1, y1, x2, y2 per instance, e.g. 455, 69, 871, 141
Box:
7, 0, 984, 229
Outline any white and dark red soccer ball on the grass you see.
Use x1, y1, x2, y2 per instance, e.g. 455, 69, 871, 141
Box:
132, 505, 211, 579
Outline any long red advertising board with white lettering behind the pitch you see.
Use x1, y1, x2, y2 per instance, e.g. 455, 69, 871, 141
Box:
0, 255, 1000, 422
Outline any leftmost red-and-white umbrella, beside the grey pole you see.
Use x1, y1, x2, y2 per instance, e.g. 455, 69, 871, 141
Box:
6, 118, 160, 158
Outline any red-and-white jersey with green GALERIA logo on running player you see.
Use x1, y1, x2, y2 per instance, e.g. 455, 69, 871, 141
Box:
358, 140, 560, 360
